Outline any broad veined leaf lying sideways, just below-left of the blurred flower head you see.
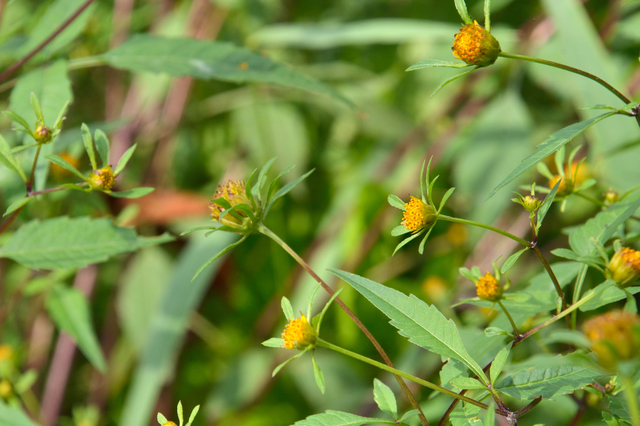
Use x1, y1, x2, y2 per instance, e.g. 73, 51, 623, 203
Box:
495, 355, 606, 400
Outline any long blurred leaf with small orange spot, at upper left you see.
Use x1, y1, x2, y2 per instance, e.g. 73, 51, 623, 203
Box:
103, 35, 351, 105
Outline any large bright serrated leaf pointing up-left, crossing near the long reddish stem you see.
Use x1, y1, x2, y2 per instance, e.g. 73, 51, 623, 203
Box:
330, 270, 487, 383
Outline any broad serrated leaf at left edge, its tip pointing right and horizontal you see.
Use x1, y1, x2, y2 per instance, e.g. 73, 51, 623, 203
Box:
0, 217, 173, 269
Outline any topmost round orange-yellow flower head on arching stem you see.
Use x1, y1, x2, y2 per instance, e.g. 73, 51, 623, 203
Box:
451, 21, 500, 67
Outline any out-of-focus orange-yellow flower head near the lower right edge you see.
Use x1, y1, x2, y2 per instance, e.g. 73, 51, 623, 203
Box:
582, 310, 640, 366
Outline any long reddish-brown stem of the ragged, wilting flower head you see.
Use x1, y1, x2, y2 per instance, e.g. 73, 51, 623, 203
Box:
258, 224, 429, 426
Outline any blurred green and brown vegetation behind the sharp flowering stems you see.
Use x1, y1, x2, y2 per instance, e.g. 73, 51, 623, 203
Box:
0, 0, 640, 426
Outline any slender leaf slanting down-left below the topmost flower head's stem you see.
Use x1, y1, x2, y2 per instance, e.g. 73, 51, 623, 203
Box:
486, 112, 615, 200
